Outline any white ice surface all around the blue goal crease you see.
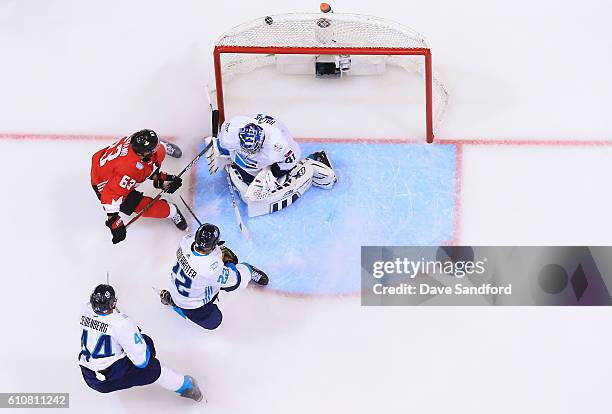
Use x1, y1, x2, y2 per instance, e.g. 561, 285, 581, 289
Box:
0, 0, 612, 413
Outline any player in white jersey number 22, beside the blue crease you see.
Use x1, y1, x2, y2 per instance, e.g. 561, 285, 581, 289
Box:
160, 223, 269, 329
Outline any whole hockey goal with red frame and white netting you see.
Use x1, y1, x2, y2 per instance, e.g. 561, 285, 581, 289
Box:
214, 13, 448, 143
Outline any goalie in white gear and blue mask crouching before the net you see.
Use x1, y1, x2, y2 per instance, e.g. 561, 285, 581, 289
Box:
207, 114, 337, 217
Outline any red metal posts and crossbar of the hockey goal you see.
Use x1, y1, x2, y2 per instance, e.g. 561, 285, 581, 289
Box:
213, 45, 434, 144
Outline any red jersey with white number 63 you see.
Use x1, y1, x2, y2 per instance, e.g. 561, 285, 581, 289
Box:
91, 137, 166, 213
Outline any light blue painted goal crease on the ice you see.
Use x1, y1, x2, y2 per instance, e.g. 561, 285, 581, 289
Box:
192, 143, 455, 294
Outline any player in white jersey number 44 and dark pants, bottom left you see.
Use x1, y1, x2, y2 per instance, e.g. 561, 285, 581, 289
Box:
79, 285, 202, 401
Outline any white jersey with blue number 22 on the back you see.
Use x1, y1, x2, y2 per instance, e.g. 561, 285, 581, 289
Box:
169, 234, 250, 309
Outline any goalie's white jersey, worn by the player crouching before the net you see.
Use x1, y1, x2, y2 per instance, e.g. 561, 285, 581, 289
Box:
218, 114, 302, 176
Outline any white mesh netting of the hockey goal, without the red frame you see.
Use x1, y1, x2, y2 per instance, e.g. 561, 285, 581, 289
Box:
213, 13, 448, 136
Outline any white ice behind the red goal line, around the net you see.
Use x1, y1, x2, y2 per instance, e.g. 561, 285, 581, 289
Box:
0, 0, 612, 139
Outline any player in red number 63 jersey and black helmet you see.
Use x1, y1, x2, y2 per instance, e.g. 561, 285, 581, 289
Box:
91, 129, 187, 243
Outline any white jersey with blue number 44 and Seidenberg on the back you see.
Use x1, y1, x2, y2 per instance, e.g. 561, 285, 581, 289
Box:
79, 303, 150, 371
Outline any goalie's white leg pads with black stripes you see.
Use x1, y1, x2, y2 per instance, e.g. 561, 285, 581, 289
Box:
229, 160, 314, 217
